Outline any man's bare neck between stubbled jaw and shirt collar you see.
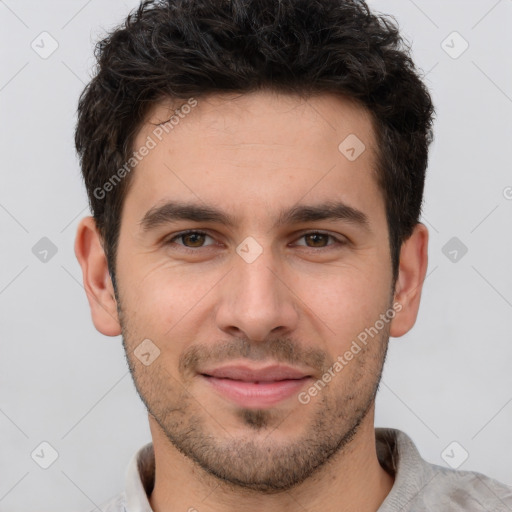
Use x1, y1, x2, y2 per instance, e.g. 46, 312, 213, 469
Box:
149, 408, 394, 512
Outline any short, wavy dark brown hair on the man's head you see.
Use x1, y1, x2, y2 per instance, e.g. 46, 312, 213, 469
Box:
75, 0, 434, 287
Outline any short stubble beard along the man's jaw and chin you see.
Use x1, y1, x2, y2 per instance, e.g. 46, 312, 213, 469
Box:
118, 302, 389, 494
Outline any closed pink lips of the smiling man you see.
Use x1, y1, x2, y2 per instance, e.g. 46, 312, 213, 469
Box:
200, 365, 312, 409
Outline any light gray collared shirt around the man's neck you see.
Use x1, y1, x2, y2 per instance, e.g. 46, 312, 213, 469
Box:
91, 428, 512, 512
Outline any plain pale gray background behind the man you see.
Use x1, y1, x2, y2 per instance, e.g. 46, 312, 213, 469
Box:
0, 0, 512, 512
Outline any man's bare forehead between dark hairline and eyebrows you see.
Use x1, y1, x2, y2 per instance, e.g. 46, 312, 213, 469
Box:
125, 92, 383, 229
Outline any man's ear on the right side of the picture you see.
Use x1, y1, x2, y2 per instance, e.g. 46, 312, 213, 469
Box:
389, 223, 428, 338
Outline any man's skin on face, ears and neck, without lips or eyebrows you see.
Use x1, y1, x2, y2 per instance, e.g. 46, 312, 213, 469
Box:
75, 92, 428, 512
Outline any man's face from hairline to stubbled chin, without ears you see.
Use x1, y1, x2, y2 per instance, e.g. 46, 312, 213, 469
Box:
116, 92, 393, 492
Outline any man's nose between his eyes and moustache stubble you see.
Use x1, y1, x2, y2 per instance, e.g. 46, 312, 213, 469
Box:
216, 242, 299, 342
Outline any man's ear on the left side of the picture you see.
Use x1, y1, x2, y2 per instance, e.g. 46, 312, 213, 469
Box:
75, 217, 121, 336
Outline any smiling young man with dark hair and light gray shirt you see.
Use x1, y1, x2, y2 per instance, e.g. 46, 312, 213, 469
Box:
75, 0, 512, 512
